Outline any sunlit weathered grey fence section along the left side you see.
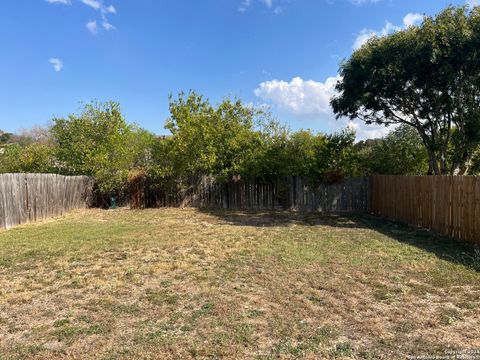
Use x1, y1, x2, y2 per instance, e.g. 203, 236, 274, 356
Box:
0, 174, 93, 229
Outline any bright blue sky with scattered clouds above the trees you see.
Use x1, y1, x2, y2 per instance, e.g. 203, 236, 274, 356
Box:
0, 0, 474, 138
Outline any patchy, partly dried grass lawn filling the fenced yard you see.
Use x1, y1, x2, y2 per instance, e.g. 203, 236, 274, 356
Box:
0, 209, 480, 359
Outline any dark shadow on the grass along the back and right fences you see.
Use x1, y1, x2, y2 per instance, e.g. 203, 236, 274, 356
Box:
197, 209, 480, 272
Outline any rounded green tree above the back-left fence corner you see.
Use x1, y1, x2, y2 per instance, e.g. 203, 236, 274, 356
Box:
51, 102, 153, 193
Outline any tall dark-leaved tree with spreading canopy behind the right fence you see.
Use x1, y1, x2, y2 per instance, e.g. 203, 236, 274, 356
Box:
332, 7, 480, 174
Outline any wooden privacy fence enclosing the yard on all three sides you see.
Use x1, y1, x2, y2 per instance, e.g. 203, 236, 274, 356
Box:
0, 174, 480, 243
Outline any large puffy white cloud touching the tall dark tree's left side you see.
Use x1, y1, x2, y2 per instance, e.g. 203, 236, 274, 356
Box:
254, 76, 389, 139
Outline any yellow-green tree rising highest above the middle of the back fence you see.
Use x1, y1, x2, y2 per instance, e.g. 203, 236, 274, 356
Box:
162, 91, 261, 178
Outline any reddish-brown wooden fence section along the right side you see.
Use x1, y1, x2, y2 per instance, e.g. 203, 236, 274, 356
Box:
372, 176, 480, 243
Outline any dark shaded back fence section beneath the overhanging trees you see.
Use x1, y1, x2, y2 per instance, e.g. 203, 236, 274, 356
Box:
130, 177, 370, 212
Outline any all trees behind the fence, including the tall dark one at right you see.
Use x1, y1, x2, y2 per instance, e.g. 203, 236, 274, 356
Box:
0, 7, 480, 194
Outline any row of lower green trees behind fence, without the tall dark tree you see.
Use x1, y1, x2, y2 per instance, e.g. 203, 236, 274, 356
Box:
0, 92, 428, 193
